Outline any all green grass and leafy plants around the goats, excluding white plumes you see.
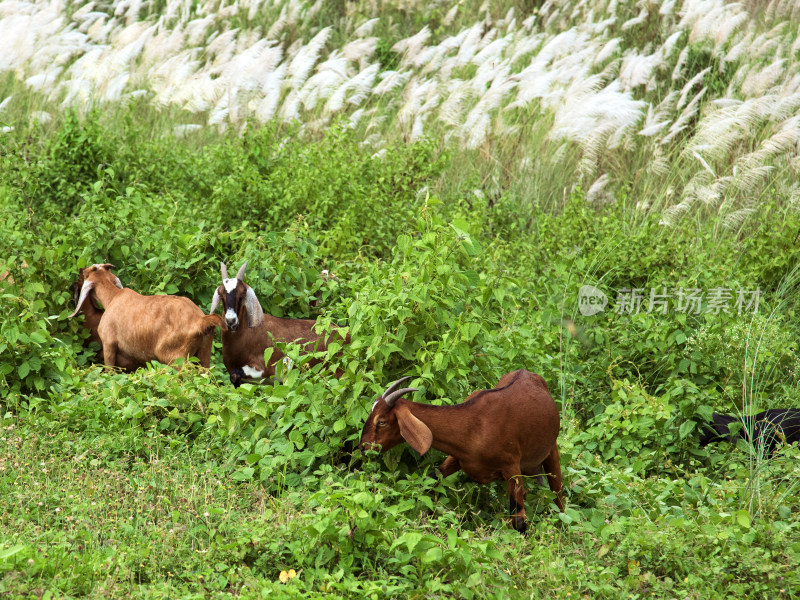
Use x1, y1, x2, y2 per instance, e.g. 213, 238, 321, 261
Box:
0, 0, 800, 600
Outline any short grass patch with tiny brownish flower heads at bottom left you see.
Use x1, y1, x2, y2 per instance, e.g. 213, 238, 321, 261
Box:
0, 418, 278, 598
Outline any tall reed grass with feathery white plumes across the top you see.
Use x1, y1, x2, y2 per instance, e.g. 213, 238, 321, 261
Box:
0, 0, 800, 220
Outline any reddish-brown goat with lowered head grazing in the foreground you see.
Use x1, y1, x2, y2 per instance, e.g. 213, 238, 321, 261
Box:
361, 370, 564, 533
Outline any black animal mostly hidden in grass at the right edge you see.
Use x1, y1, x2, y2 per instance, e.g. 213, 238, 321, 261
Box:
700, 408, 800, 453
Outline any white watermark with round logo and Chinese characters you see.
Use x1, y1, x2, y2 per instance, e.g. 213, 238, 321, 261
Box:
578, 285, 764, 317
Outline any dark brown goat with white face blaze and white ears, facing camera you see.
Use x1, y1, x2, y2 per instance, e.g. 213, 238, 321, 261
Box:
209, 262, 350, 387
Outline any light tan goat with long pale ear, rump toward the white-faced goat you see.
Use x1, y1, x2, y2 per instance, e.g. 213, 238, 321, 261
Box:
70, 264, 225, 369
